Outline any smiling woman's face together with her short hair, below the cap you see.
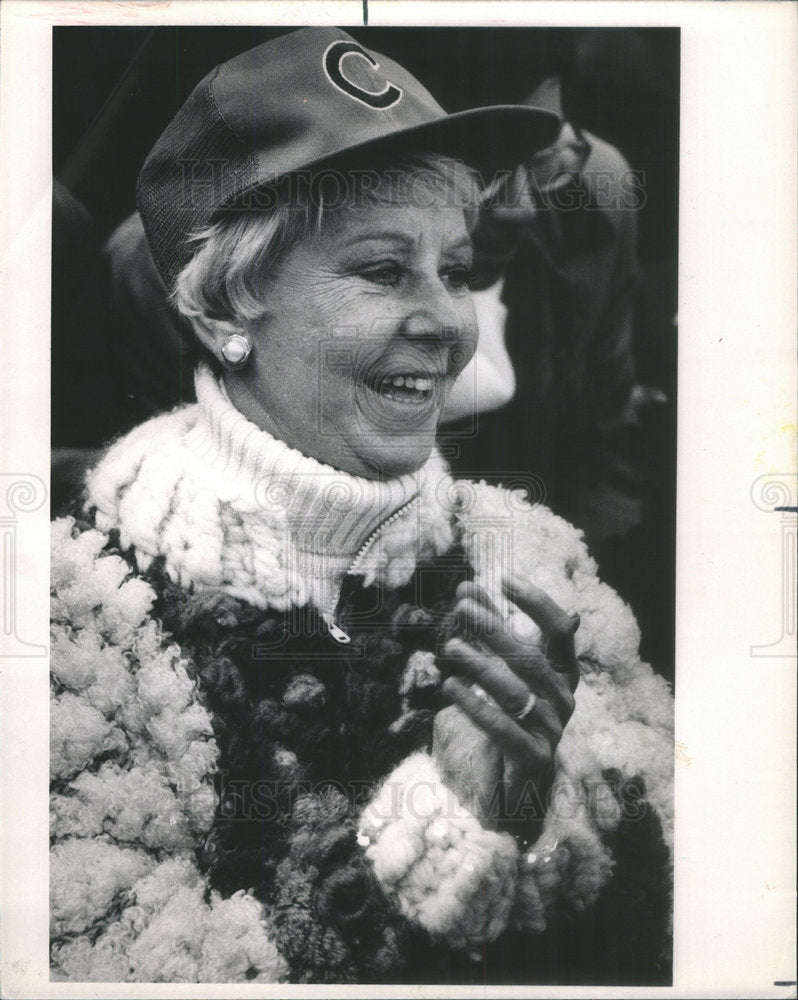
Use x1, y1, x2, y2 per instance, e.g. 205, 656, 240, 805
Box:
174, 155, 479, 478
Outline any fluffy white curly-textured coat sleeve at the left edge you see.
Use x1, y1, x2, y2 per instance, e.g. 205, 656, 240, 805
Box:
50, 519, 287, 982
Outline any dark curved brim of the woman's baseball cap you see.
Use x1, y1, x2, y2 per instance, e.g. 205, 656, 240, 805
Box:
231, 104, 562, 208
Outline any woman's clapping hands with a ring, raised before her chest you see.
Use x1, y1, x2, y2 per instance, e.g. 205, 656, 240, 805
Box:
433, 578, 579, 836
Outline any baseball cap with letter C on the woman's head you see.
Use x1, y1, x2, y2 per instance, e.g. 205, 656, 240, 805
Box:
136, 27, 560, 288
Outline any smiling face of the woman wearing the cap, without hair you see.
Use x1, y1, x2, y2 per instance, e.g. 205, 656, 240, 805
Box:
226, 198, 477, 478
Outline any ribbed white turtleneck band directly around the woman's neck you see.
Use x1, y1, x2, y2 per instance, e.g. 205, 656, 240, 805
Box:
195, 364, 434, 564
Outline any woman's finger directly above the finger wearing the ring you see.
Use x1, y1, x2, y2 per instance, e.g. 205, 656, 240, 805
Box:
444, 598, 573, 718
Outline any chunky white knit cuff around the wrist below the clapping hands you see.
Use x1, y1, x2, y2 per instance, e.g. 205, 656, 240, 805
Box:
358, 753, 518, 948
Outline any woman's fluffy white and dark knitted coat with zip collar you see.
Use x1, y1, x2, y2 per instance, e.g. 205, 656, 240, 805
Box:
51, 362, 673, 983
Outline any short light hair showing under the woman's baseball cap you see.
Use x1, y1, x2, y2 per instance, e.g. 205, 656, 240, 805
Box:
172, 153, 480, 328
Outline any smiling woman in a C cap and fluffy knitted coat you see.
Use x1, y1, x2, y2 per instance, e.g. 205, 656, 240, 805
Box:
51, 29, 672, 983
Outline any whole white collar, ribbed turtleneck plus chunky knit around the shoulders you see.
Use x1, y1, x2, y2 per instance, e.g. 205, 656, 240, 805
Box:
87, 365, 451, 613
